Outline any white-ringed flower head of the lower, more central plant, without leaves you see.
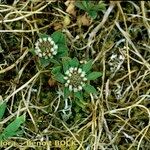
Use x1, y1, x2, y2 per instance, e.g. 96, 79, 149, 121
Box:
64, 67, 87, 92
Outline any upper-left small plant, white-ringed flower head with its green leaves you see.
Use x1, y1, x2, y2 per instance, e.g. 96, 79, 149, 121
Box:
32, 31, 68, 67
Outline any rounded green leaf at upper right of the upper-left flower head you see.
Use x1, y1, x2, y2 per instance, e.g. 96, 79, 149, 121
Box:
51, 31, 66, 45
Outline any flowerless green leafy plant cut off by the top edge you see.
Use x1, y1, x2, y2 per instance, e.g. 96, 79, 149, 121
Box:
76, 0, 106, 19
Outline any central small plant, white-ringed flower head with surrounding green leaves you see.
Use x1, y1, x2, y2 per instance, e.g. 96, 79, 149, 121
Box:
52, 58, 101, 99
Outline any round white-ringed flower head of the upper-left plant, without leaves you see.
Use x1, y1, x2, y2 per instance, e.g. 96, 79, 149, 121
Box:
35, 37, 58, 59
